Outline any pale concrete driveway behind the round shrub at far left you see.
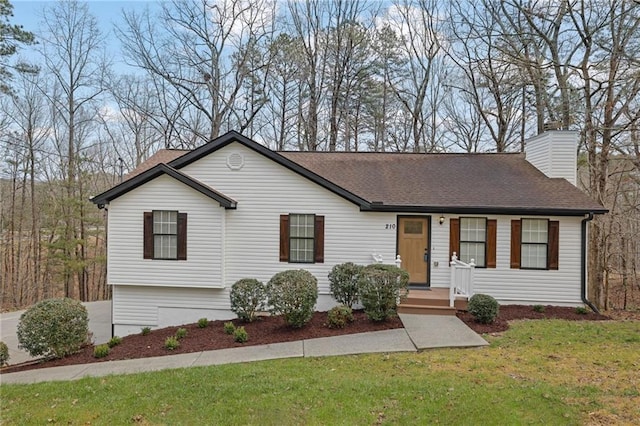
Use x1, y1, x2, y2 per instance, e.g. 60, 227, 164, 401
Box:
0, 300, 111, 364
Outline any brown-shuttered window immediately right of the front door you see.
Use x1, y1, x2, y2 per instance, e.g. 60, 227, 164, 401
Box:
449, 217, 497, 268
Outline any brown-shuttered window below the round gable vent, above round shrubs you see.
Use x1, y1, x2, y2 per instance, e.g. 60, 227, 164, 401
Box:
280, 214, 324, 263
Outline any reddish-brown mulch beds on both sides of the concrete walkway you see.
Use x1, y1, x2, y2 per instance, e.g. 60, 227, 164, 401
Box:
0, 305, 610, 373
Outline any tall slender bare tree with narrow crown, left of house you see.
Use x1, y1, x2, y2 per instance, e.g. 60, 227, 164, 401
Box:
40, 0, 108, 300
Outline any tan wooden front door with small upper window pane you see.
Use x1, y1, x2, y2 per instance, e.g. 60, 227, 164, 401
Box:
398, 216, 429, 286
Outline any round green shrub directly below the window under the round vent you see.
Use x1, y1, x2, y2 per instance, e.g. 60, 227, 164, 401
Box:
267, 269, 318, 328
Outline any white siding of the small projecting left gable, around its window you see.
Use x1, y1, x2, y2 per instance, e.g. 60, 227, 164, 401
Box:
107, 175, 225, 288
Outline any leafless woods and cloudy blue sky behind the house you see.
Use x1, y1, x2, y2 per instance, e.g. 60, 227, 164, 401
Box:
0, 0, 640, 309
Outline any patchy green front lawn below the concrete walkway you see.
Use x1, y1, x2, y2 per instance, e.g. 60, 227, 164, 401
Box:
0, 320, 640, 425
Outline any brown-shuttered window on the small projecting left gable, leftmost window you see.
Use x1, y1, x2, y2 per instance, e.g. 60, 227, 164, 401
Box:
143, 210, 187, 260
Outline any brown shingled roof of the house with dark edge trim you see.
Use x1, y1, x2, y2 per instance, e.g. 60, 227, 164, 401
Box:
92, 132, 607, 215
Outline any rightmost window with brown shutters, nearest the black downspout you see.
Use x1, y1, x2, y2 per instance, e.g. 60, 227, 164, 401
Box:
511, 219, 560, 269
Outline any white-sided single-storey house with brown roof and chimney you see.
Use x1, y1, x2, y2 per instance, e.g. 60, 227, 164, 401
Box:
92, 131, 606, 336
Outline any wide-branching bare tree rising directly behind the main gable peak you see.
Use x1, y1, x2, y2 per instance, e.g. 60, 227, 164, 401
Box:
117, 0, 275, 141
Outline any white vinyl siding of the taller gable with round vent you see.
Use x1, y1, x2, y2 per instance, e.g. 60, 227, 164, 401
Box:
181, 143, 397, 295
